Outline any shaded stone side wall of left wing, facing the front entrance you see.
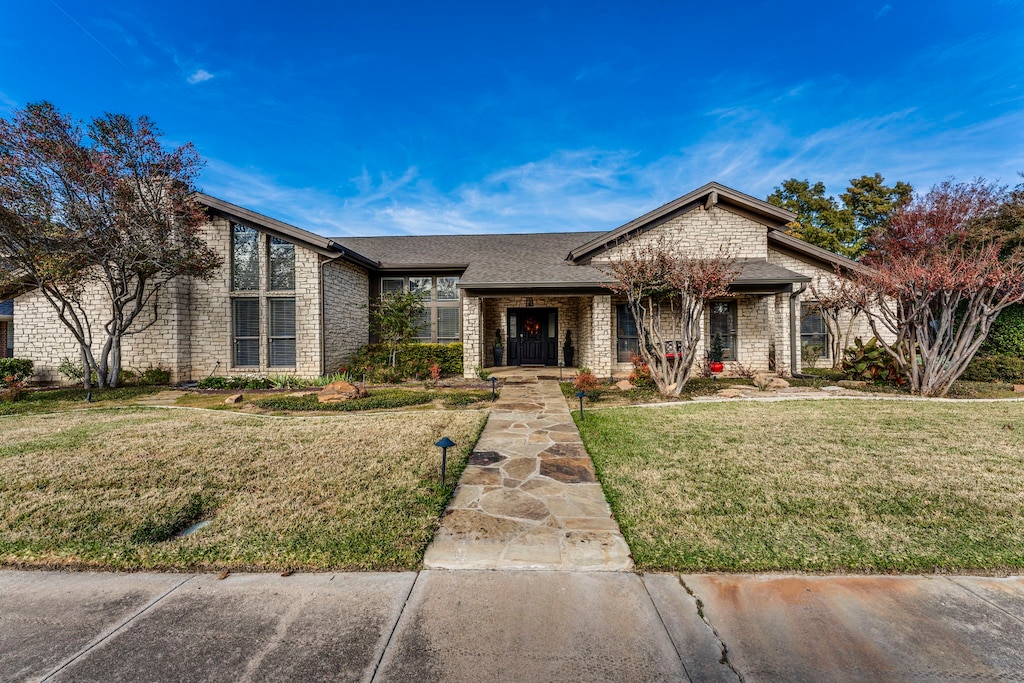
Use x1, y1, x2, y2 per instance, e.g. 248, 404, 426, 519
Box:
324, 261, 370, 373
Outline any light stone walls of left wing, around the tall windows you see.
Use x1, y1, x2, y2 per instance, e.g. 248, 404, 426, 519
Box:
14, 217, 369, 382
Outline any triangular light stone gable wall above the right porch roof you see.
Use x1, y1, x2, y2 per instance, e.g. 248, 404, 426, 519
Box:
593, 205, 768, 263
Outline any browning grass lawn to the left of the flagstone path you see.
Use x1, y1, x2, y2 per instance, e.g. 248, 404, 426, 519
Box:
0, 408, 485, 570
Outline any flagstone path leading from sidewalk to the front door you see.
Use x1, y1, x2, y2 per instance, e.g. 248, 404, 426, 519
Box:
424, 380, 633, 571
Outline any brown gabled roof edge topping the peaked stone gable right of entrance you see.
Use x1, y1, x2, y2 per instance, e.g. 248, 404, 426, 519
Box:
568, 182, 797, 262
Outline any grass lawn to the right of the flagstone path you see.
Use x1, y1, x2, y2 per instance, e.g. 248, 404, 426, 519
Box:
573, 400, 1024, 572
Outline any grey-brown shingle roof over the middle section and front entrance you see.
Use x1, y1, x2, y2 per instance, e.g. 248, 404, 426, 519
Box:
334, 232, 609, 288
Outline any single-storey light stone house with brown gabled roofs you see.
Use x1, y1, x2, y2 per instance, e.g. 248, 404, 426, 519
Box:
12, 182, 857, 381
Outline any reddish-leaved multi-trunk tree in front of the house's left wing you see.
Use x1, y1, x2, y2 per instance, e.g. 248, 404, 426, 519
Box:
0, 102, 222, 387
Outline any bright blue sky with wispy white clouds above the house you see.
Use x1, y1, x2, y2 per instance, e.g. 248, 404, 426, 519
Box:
0, 0, 1024, 236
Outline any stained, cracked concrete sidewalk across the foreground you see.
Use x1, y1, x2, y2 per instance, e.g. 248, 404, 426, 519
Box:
0, 570, 1024, 683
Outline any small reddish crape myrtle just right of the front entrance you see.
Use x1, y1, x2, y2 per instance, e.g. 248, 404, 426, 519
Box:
606, 240, 738, 396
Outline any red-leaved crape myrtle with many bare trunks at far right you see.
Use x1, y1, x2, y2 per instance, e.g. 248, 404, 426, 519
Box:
849, 180, 1024, 396
